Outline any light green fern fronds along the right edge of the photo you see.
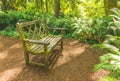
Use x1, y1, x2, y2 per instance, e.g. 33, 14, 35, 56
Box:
93, 8, 120, 81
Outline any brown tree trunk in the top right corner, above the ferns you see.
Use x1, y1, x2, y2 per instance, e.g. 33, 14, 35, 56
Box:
104, 0, 117, 15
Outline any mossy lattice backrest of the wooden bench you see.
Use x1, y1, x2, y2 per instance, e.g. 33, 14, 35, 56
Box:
16, 19, 49, 41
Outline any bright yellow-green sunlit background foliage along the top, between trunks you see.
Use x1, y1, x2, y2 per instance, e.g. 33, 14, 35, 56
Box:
1, 0, 105, 18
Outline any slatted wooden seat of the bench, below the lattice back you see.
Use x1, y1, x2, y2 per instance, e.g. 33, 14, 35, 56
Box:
27, 35, 62, 54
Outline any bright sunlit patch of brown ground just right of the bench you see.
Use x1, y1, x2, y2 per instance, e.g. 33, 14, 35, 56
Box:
54, 41, 89, 68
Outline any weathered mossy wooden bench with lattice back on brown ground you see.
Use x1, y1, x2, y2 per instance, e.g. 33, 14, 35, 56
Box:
16, 19, 64, 66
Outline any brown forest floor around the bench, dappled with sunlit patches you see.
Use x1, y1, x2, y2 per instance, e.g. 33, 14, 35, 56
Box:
0, 36, 109, 81
